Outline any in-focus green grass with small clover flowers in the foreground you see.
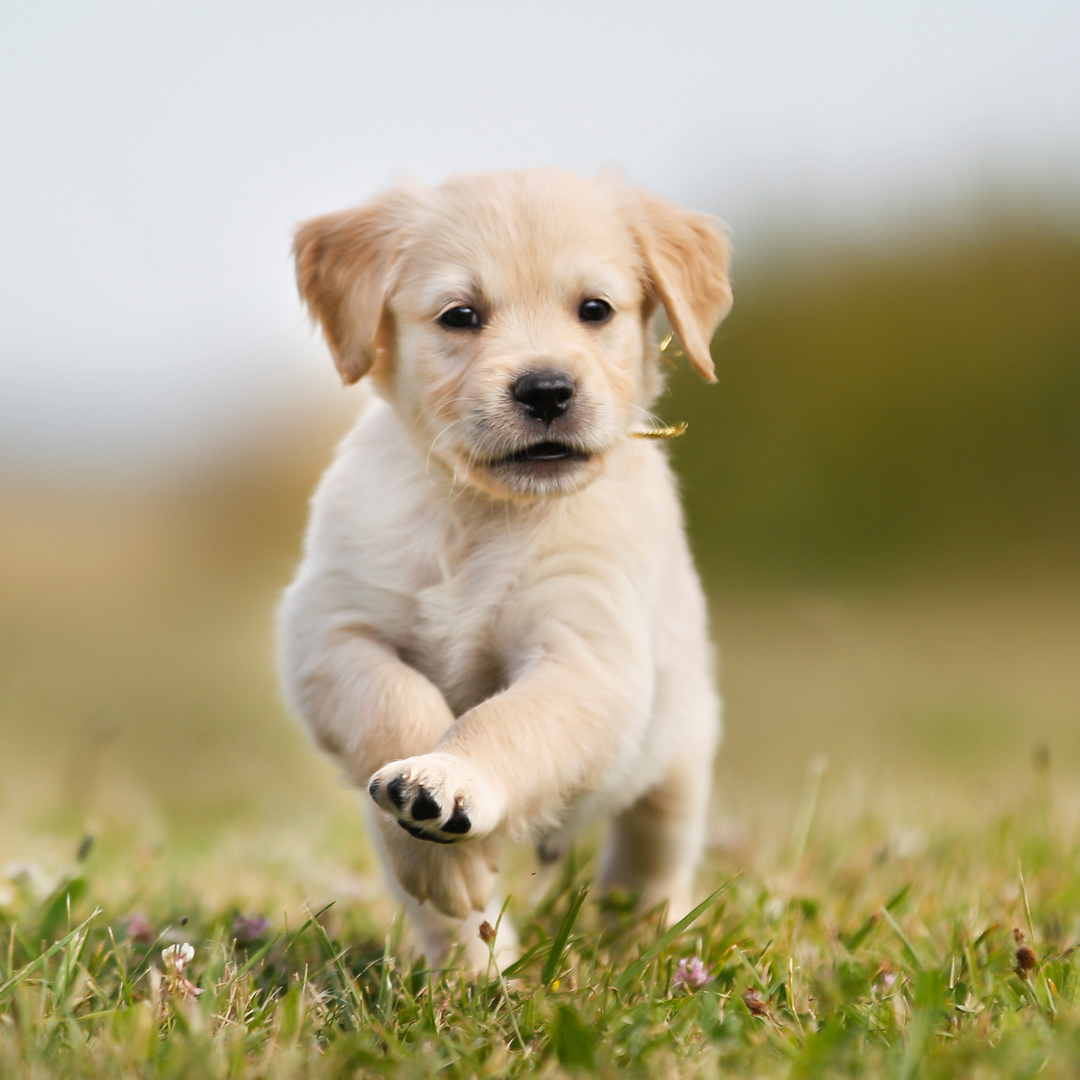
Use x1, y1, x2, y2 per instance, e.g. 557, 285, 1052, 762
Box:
0, 761, 1080, 1080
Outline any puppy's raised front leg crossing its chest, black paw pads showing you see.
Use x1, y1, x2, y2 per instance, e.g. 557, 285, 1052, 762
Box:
368, 593, 652, 845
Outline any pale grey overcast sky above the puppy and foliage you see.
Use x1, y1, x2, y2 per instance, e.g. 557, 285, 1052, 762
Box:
0, 0, 1080, 475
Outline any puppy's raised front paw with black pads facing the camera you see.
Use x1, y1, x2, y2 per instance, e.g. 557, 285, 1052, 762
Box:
367, 754, 501, 843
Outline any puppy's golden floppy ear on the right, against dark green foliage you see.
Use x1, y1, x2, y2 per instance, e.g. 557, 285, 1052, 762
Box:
631, 192, 731, 382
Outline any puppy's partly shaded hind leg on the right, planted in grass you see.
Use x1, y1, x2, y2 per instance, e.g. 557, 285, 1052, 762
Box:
599, 754, 712, 922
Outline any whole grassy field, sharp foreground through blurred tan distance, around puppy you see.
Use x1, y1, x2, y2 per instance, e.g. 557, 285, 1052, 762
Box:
0, 475, 1080, 1078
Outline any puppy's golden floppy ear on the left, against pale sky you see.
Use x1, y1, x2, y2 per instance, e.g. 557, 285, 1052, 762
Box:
293, 189, 416, 384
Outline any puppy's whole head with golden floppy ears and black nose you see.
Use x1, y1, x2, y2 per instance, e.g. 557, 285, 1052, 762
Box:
295, 171, 731, 498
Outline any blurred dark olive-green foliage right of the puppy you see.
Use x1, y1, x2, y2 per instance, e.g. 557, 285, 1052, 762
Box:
661, 225, 1080, 581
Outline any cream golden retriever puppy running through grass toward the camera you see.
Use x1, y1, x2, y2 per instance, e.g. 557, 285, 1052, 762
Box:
280, 170, 731, 967
